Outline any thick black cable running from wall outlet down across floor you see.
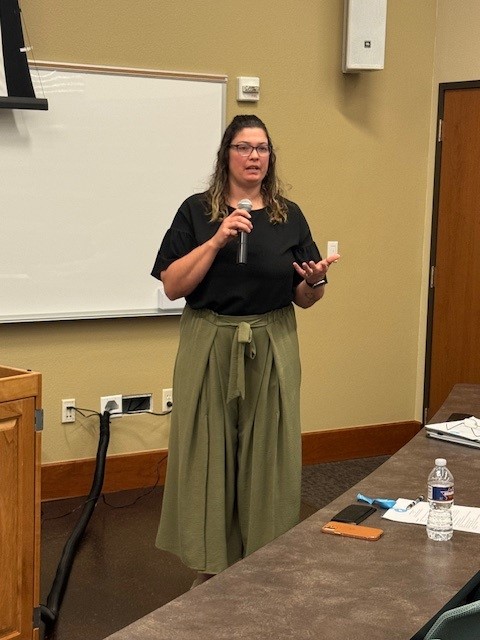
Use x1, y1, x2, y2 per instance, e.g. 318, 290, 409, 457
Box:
40, 411, 110, 638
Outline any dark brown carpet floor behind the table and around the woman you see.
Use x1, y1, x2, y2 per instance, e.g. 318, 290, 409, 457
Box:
41, 457, 387, 640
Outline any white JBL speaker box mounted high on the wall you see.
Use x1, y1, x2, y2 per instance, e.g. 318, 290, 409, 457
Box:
342, 0, 387, 73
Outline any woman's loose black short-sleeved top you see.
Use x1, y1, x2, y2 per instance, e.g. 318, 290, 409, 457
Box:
152, 194, 321, 316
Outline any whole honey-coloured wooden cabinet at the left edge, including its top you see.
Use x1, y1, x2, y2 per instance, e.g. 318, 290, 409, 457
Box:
0, 366, 41, 640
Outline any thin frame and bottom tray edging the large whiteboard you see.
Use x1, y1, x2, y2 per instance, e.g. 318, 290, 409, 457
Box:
0, 61, 227, 324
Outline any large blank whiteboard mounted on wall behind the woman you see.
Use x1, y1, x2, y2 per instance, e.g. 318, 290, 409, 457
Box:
0, 63, 226, 323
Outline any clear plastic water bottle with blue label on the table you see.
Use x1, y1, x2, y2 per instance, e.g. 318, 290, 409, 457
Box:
427, 458, 454, 541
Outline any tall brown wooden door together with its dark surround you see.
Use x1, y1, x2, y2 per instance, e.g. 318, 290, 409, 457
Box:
425, 82, 480, 419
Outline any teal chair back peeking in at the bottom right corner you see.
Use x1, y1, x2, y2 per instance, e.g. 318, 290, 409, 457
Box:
424, 600, 480, 640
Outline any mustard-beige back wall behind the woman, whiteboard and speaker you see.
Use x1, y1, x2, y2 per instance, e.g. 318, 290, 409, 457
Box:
0, 0, 436, 462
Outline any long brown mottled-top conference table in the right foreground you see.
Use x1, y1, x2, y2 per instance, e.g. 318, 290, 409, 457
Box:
108, 384, 480, 640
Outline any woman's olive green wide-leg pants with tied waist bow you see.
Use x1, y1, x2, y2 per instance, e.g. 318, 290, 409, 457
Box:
156, 306, 301, 573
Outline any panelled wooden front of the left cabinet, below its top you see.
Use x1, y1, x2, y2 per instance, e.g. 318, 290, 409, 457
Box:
0, 398, 36, 640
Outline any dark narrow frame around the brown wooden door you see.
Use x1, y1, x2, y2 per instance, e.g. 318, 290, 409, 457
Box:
423, 80, 480, 423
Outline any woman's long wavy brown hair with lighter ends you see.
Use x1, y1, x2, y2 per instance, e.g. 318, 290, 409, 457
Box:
205, 115, 287, 223
